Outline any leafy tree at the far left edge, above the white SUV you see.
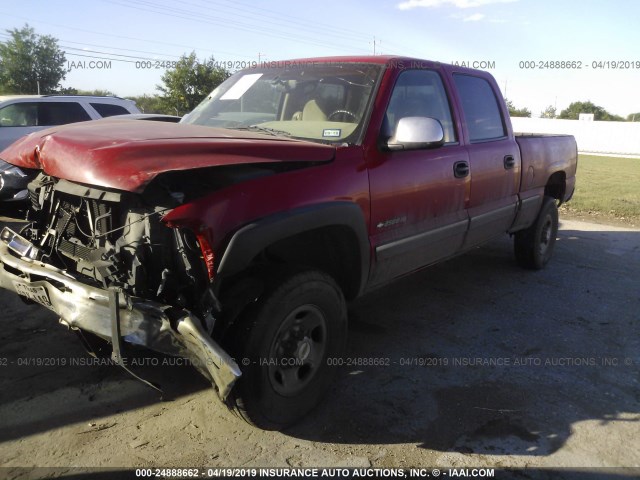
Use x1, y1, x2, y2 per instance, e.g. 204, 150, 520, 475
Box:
0, 25, 67, 94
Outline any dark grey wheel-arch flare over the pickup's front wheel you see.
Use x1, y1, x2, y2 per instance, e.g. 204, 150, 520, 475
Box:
217, 201, 371, 295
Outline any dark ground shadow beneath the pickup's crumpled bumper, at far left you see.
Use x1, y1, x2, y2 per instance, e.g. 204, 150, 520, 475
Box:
0, 290, 208, 442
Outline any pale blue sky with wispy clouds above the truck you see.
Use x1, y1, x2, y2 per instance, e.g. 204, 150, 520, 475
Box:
0, 0, 640, 117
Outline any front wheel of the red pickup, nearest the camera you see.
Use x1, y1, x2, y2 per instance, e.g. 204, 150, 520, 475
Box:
224, 271, 347, 430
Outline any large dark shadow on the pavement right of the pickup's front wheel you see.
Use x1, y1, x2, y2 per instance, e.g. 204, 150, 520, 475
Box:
287, 227, 640, 456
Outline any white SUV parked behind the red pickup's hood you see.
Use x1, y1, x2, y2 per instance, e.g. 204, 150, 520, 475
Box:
0, 95, 140, 152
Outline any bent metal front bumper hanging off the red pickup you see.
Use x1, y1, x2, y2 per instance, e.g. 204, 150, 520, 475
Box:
0, 227, 241, 400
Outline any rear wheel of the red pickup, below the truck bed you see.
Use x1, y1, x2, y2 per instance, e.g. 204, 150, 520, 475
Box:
513, 197, 558, 270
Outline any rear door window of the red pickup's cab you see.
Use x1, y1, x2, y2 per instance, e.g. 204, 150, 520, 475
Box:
453, 73, 507, 143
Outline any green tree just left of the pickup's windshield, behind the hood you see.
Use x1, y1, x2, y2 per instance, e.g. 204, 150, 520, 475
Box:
156, 52, 230, 115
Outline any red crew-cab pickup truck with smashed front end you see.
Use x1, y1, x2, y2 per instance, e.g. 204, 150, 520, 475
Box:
0, 56, 577, 428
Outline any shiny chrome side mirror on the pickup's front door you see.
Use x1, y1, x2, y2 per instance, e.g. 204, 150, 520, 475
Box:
385, 117, 444, 150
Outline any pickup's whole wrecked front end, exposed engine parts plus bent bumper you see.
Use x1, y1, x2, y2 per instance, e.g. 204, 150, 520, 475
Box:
0, 174, 241, 399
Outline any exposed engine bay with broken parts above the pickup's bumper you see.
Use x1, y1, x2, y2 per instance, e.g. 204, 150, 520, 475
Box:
21, 174, 210, 317
